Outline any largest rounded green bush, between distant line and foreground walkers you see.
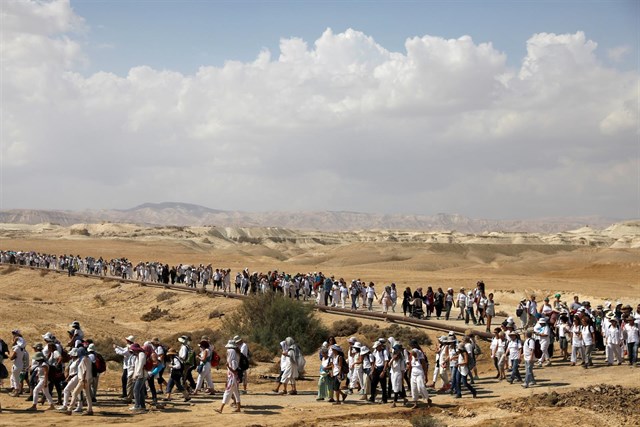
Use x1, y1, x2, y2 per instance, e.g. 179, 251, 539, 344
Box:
222, 293, 327, 356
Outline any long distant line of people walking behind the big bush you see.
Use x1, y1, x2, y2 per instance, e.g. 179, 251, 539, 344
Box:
0, 251, 495, 331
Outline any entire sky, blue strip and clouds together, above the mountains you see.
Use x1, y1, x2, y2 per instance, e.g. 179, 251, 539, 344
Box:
0, 0, 640, 219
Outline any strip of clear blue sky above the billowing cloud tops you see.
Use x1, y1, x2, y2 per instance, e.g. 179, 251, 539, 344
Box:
71, 0, 640, 75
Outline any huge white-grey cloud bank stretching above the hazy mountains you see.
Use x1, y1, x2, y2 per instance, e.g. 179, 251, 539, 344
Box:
1, 1, 638, 218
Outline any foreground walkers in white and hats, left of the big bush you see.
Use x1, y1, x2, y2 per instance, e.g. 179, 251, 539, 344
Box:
0, 321, 249, 415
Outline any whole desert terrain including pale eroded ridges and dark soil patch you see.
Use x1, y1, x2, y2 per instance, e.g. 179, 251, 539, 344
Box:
0, 221, 640, 426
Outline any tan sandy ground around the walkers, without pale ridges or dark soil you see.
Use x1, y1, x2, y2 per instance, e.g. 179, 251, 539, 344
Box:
0, 229, 640, 426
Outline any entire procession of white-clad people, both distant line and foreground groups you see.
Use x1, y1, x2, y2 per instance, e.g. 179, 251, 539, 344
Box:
0, 251, 640, 415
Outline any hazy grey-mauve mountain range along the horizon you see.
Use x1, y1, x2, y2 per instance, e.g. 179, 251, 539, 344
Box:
0, 202, 620, 233
